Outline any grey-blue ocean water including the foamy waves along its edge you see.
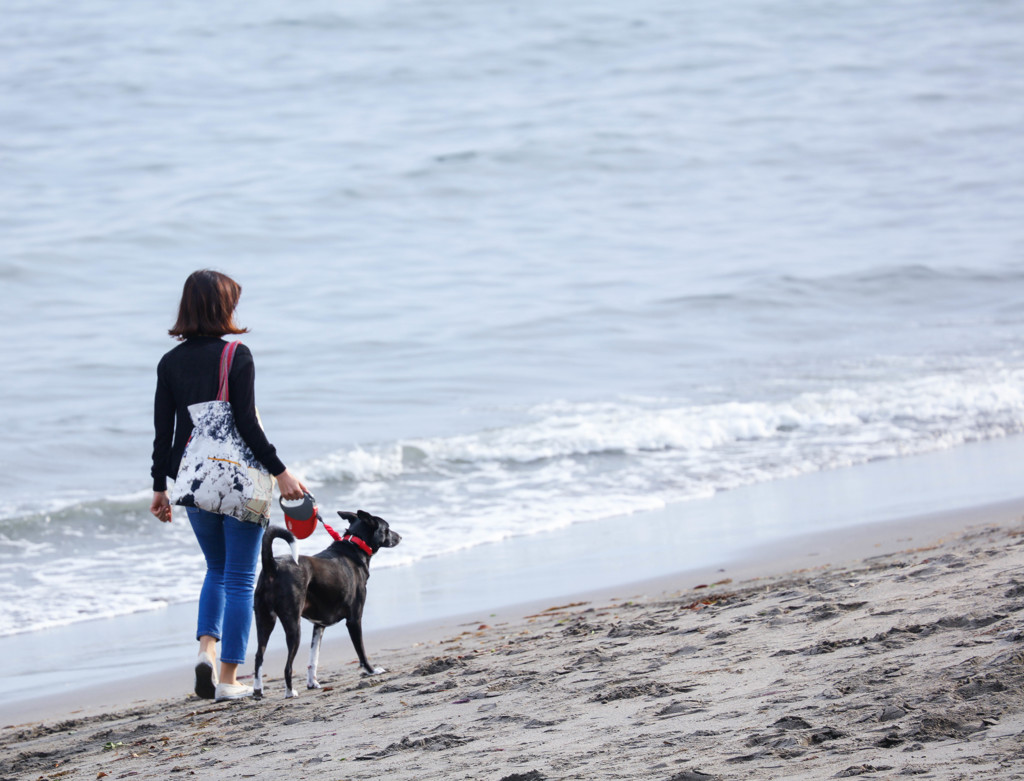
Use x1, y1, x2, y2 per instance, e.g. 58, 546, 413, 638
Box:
0, 0, 1024, 635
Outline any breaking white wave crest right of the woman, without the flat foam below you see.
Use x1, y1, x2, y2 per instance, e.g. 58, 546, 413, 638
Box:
303, 368, 1024, 483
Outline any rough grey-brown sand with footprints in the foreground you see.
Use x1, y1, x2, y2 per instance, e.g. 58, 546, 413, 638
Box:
6, 516, 1024, 781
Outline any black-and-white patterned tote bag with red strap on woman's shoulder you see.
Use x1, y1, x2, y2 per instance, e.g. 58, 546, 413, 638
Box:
170, 342, 273, 527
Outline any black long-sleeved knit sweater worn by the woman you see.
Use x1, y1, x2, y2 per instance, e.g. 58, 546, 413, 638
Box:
152, 337, 285, 491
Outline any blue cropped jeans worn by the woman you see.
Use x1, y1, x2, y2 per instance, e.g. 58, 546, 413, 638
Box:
185, 507, 263, 664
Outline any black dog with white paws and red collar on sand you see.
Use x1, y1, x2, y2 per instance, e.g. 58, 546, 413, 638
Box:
253, 510, 401, 697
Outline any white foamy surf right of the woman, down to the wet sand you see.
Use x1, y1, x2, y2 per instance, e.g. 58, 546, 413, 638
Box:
284, 368, 1024, 563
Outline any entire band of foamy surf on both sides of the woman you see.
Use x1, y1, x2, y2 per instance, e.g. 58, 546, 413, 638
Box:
0, 365, 1024, 635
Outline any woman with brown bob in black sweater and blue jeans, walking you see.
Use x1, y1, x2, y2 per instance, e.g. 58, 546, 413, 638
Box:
150, 270, 305, 701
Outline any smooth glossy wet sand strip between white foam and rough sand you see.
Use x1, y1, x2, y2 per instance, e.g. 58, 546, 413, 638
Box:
9, 437, 1024, 726
